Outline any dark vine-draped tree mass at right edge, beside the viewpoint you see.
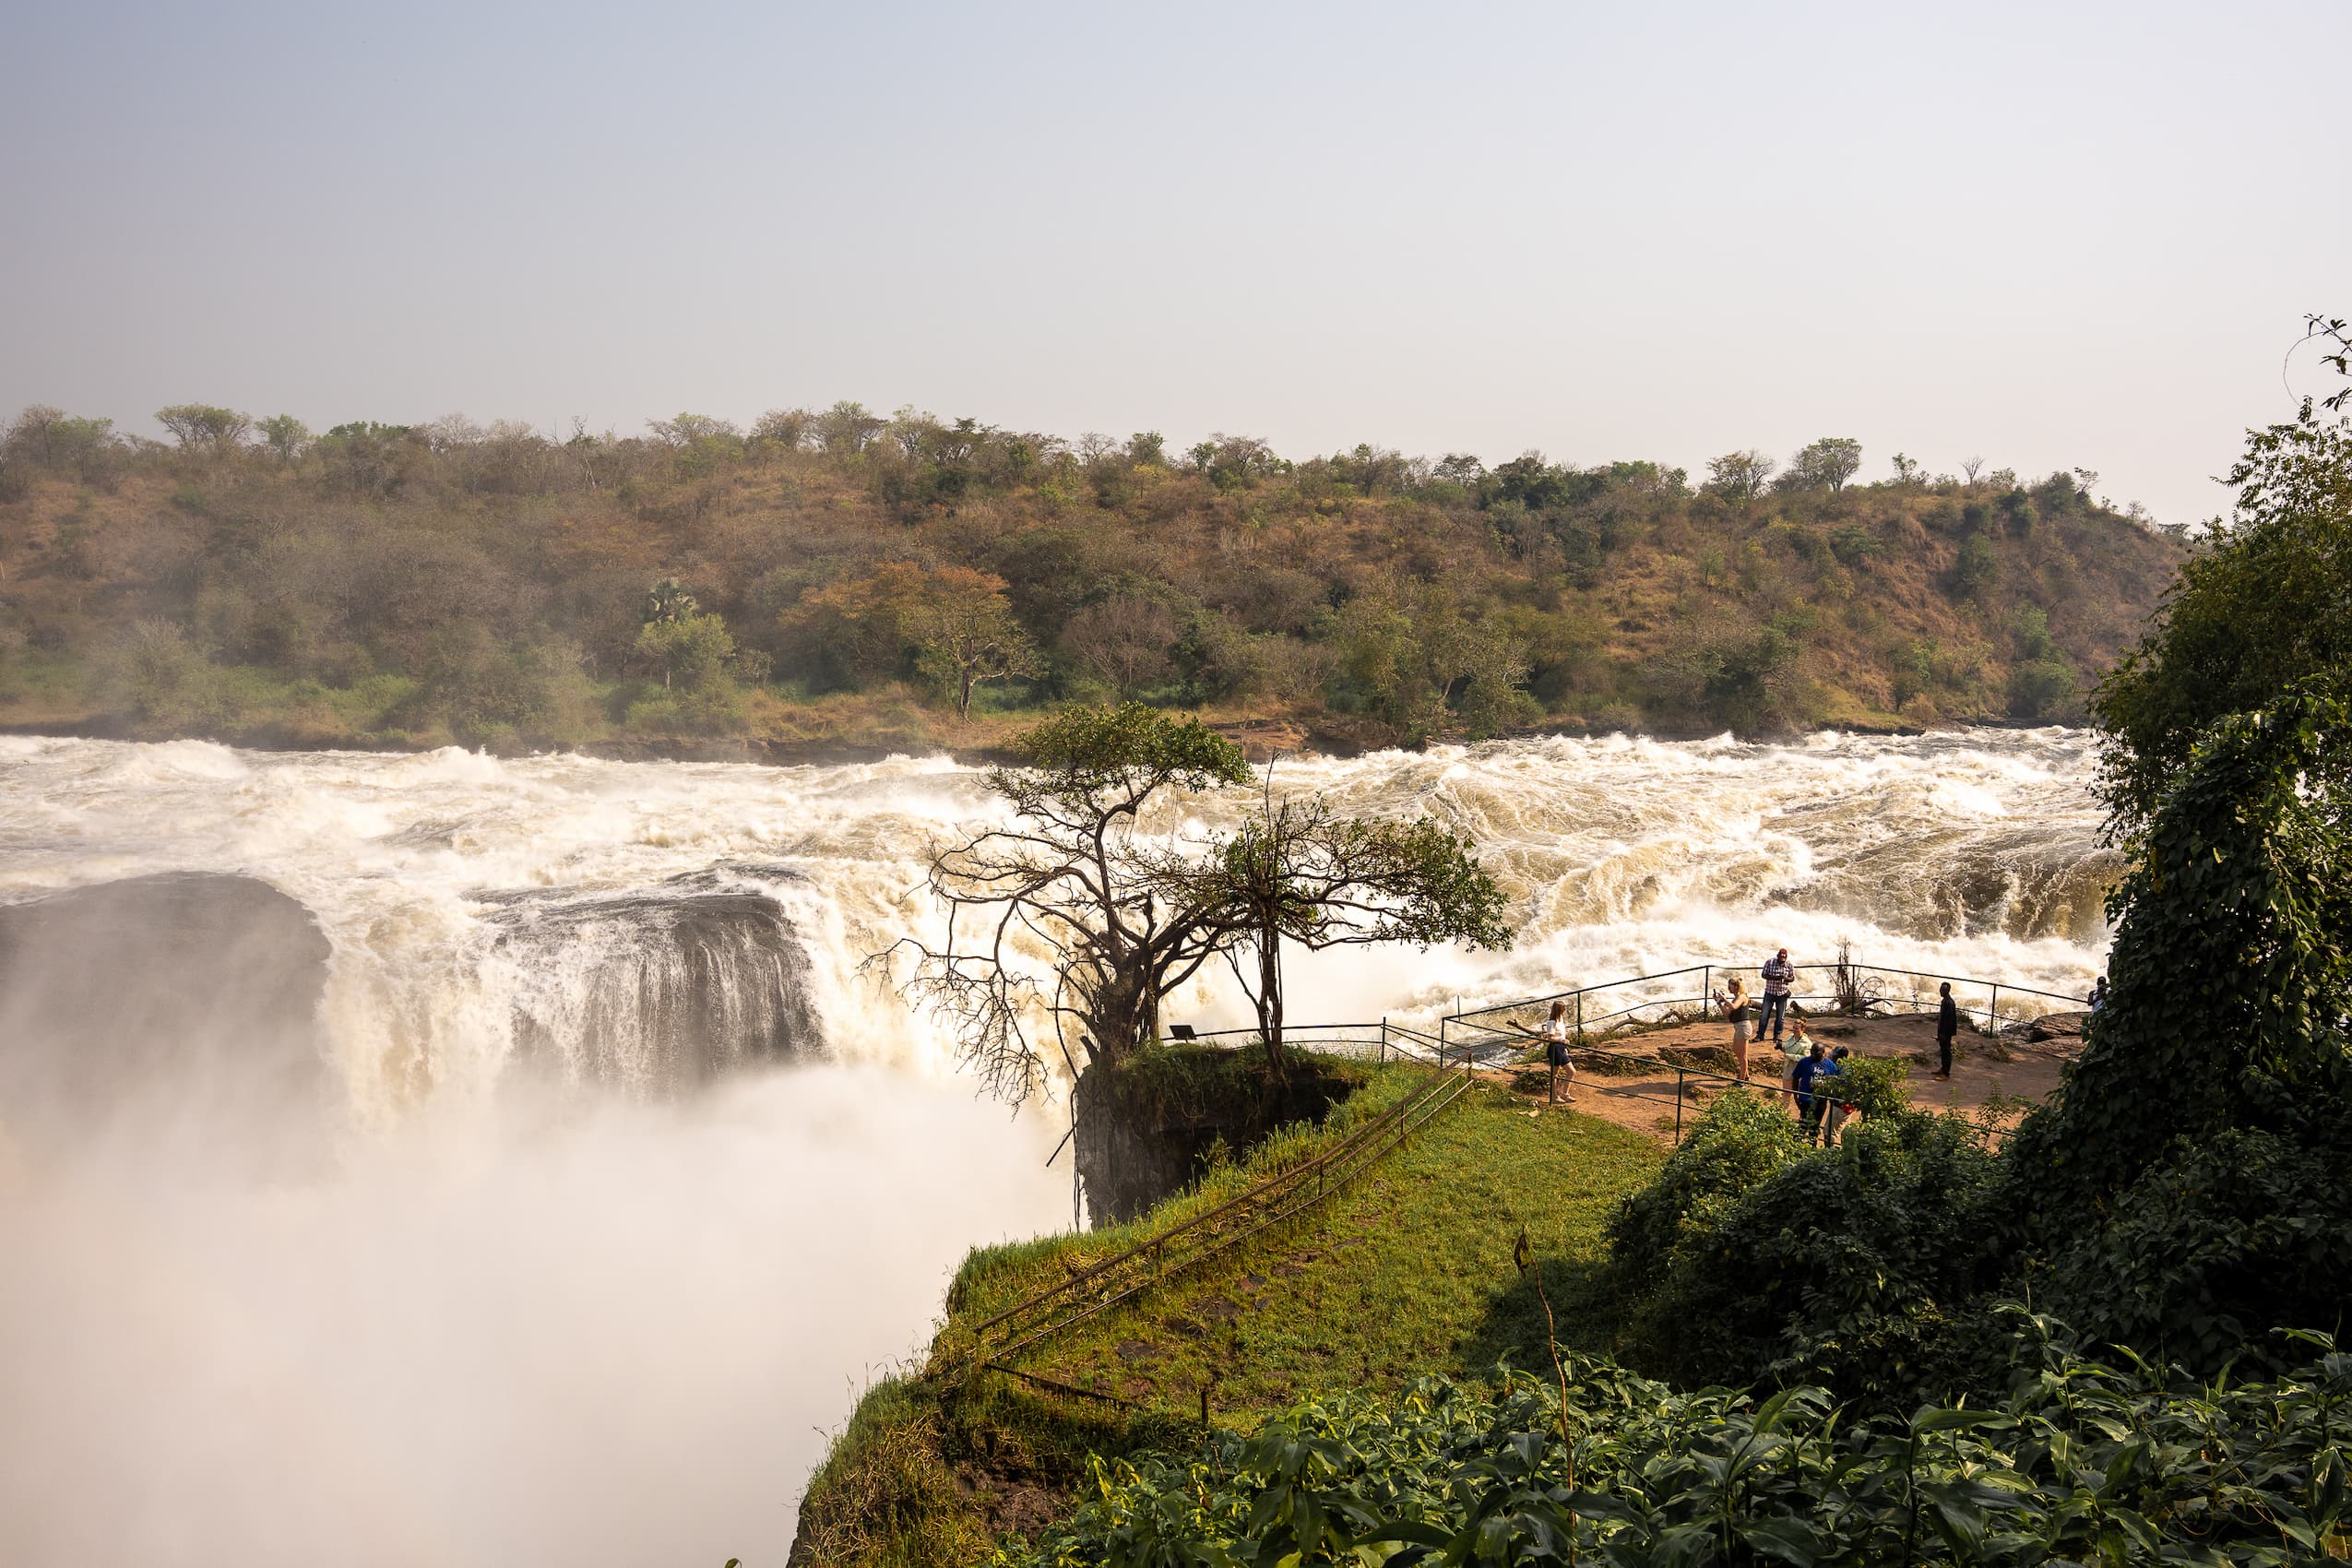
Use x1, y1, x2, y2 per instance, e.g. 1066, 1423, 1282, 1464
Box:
2011, 674, 2352, 1366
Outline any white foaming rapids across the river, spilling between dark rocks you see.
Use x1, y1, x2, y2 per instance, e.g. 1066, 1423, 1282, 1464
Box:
0, 729, 2112, 1109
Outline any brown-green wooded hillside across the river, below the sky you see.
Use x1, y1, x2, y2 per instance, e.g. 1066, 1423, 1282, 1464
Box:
0, 402, 2182, 742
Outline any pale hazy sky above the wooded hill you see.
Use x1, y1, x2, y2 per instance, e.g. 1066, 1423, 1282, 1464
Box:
0, 0, 2352, 519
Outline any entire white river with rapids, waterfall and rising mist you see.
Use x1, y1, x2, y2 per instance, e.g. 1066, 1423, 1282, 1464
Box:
0, 731, 2112, 1568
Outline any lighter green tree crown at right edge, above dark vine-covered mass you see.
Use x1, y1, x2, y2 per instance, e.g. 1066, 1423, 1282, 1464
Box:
2091, 402, 2352, 837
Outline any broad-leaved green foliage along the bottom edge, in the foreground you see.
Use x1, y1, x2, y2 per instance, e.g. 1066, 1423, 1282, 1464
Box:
997, 1314, 2352, 1568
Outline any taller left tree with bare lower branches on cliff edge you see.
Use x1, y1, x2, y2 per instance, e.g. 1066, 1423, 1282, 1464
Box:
873, 703, 1249, 1102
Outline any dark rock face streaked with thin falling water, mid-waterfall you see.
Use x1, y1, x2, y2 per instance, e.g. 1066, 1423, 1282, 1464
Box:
489, 867, 824, 1093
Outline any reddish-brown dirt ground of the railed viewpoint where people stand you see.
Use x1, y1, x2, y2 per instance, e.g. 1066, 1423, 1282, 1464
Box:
1479, 1014, 2082, 1140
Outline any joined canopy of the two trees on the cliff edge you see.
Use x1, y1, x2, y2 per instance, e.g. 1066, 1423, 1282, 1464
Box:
875, 703, 1510, 1100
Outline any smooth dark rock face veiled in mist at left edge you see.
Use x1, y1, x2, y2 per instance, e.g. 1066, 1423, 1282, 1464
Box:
0, 874, 334, 1152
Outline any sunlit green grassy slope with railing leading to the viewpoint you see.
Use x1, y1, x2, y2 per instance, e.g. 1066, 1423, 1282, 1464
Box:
800, 1067, 1663, 1563
